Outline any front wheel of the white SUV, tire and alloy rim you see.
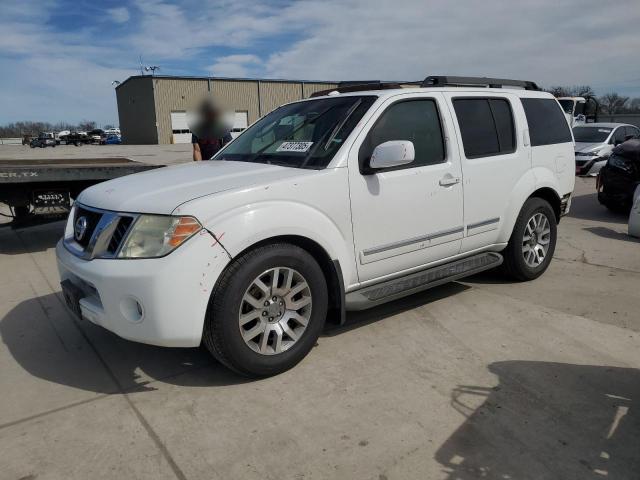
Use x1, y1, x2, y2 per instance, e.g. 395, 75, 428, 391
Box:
202, 243, 328, 377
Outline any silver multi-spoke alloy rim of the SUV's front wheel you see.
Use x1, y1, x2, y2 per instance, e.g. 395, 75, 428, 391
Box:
238, 267, 312, 355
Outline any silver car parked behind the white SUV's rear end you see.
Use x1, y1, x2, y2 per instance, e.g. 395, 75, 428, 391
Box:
573, 123, 640, 176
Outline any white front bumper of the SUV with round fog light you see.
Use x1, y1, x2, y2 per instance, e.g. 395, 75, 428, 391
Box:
56, 230, 229, 347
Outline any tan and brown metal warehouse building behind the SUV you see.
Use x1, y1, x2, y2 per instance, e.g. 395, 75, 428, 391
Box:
116, 76, 337, 144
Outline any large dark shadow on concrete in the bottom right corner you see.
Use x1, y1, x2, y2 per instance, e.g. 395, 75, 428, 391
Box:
435, 361, 640, 480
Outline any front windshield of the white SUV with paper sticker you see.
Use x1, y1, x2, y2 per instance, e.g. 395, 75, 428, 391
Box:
213, 96, 377, 169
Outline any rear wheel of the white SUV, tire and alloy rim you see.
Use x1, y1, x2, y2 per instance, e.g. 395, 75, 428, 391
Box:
502, 197, 558, 281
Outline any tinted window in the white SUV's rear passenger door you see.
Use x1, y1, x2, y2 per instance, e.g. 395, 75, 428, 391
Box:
453, 97, 515, 158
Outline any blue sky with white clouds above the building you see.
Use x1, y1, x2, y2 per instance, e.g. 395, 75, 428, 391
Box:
0, 0, 640, 124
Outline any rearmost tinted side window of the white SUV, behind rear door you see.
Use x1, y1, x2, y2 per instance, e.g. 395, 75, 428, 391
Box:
521, 98, 572, 147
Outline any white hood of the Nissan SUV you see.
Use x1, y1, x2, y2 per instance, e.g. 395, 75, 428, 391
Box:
78, 161, 314, 214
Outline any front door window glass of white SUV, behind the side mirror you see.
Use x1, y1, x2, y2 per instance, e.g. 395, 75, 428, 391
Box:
359, 100, 444, 169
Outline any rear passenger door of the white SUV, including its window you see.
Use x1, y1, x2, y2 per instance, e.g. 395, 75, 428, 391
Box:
445, 92, 531, 252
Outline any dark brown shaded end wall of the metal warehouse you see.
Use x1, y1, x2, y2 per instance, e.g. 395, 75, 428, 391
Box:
116, 77, 158, 145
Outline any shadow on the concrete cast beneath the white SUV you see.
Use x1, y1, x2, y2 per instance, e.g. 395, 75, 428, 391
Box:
0, 284, 468, 394
